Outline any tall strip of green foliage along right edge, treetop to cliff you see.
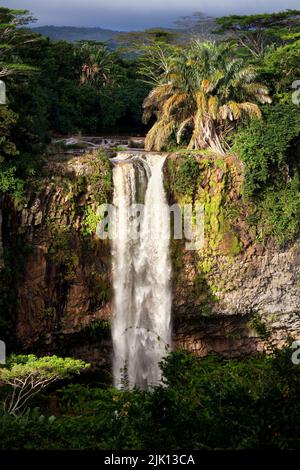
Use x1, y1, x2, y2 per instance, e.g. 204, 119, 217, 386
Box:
227, 26, 300, 245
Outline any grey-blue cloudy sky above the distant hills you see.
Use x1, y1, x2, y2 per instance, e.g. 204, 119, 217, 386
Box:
5, 0, 300, 31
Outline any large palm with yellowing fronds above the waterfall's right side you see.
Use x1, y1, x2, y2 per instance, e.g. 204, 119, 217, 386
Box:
143, 40, 271, 154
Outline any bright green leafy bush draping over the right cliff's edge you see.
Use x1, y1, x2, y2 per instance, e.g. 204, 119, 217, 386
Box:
233, 103, 300, 244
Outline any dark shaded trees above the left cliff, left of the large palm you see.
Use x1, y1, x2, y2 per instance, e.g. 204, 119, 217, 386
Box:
8, 41, 147, 137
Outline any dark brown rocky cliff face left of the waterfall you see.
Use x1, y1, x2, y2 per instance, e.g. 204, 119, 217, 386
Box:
0, 152, 112, 365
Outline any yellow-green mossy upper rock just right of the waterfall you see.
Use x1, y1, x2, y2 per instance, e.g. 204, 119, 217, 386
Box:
165, 154, 243, 308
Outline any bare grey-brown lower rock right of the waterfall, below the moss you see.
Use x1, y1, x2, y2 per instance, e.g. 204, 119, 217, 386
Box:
174, 243, 300, 356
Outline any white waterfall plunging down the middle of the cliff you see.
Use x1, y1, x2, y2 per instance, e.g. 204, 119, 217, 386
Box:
112, 154, 171, 388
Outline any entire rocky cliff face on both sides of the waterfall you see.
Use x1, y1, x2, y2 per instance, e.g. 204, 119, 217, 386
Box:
0, 152, 300, 367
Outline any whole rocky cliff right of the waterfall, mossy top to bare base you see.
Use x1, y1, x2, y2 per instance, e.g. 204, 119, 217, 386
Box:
165, 155, 300, 356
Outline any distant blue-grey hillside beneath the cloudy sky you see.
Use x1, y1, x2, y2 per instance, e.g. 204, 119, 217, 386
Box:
31, 26, 119, 43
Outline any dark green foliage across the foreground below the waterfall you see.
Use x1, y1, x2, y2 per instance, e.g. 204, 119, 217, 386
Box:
0, 349, 300, 450
